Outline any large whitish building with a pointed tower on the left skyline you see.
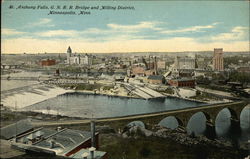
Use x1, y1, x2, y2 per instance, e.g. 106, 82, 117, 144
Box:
67, 46, 92, 65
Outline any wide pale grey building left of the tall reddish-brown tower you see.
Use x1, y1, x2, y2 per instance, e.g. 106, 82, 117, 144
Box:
174, 56, 195, 69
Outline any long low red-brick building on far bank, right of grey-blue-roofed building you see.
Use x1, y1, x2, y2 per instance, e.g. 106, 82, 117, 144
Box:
168, 78, 195, 88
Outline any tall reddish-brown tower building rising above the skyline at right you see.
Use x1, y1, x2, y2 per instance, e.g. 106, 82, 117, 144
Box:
213, 48, 224, 71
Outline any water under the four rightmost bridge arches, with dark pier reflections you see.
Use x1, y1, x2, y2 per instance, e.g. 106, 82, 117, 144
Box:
159, 105, 250, 142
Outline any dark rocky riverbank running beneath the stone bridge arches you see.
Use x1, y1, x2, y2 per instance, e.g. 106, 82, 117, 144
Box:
118, 126, 250, 157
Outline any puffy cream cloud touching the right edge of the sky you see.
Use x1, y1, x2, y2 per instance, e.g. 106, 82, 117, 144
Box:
211, 26, 249, 41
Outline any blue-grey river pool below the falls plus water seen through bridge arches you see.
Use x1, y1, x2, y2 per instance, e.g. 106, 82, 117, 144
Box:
23, 93, 250, 142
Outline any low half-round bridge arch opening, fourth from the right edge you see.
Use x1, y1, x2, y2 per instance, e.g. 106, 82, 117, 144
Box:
158, 116, 184, 129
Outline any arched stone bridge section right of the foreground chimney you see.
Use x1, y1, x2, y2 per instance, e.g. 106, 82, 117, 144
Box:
97, 101, 248, 134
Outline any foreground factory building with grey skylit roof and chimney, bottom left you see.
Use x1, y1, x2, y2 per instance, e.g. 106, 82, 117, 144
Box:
1, 120, 108, 159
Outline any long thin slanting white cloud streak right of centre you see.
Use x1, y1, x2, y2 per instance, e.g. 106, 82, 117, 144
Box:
161, 22, 219, 34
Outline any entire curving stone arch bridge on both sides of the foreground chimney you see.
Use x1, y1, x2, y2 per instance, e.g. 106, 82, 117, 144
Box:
33, 101, 249, 137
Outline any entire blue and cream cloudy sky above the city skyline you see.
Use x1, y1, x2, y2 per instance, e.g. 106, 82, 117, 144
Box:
1, 0, 249, 53
